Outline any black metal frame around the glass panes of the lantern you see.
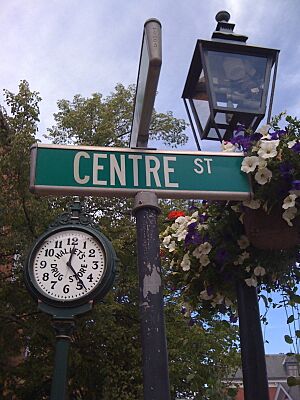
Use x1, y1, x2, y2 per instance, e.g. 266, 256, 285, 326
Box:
182, 40, 279, 145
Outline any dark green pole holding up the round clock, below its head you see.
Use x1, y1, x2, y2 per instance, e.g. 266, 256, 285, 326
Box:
50, 319, 74, 400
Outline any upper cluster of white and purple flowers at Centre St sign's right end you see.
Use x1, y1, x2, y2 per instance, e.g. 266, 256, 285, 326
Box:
222, 114, 300, 226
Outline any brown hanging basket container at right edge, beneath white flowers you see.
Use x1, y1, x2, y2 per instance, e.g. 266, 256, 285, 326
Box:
243, 207, 300, 250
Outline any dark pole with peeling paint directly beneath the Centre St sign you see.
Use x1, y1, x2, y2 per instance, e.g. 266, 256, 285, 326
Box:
133, 192, 170, 400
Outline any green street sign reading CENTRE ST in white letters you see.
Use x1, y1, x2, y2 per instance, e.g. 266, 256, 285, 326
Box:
30, 143, 251, 200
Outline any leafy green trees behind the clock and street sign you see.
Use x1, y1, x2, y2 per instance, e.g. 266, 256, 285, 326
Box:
0, 81, 237, 400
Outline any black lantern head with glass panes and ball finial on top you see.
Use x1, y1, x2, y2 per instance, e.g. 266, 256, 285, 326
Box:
182, 11, 279, 149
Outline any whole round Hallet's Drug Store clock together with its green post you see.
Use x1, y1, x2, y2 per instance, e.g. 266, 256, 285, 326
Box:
25, 197, 116, 400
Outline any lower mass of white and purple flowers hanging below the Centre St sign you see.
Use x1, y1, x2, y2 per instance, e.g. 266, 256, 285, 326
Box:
161, 202, 300, 318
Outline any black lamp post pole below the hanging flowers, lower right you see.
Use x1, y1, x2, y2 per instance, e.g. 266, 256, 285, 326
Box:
237, 281, 269, 400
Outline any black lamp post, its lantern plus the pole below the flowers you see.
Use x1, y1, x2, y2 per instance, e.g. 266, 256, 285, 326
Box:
182, 11, 279, 400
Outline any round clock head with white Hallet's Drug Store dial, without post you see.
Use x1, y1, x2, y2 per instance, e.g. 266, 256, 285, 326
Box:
25, 203, 116, 308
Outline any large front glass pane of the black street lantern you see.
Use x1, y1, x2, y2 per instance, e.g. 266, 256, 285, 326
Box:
207, 50, 268, 113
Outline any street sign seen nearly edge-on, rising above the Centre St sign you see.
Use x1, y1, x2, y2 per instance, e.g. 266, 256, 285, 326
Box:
130, 18, 162, 147
